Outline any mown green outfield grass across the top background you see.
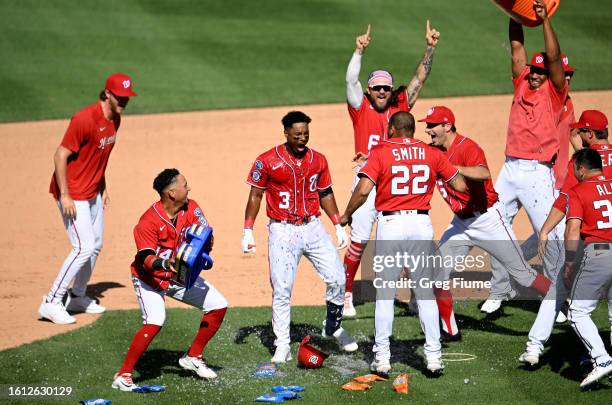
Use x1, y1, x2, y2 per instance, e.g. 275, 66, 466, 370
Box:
0, 0, 612, 122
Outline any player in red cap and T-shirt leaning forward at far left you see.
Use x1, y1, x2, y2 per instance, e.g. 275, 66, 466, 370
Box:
38, 73, 136, 324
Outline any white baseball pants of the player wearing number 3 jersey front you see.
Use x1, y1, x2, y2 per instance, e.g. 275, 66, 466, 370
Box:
268, 218, 346, 346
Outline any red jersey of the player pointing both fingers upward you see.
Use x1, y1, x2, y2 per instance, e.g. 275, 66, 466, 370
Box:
347, 90, 410, 154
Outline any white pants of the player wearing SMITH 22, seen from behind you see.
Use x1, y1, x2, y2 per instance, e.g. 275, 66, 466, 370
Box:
372, 213, 442, 361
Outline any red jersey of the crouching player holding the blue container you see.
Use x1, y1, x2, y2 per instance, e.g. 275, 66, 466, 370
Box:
131, 200, 208, 290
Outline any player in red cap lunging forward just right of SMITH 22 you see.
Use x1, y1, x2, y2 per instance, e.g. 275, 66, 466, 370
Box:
419, 106, 550, 340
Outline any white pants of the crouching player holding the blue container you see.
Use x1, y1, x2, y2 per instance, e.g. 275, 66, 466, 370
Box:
132, 275, 227, 326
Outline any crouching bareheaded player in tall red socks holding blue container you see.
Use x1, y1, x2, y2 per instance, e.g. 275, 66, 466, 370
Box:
112, 169, 227, 391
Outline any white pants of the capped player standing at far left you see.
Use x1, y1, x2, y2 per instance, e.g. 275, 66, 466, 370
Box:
47, 193, 104, 302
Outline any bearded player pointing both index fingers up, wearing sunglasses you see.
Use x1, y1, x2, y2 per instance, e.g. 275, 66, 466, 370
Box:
344, 20, 440, 316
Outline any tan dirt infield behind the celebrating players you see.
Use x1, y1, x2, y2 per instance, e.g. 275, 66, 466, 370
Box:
0, 91, 612, 350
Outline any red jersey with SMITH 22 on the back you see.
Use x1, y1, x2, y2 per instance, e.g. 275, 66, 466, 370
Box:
359, 138, 458, 211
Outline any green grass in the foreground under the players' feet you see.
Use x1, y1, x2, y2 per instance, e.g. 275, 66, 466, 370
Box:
0, 301, 612, 405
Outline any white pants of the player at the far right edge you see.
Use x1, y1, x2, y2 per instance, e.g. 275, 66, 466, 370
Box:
568, 244, 612, 364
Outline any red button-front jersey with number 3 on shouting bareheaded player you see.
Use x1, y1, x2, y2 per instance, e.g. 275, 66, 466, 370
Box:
247, 144, 332, 221
